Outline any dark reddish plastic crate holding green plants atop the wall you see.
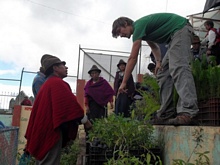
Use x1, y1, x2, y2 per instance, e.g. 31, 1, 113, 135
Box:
195, 98, 220, 126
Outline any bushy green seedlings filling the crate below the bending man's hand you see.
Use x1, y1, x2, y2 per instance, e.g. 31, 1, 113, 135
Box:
89, 114, 153, 149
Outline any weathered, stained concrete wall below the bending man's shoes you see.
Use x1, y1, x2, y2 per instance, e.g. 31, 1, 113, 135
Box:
155, 126, 220, 165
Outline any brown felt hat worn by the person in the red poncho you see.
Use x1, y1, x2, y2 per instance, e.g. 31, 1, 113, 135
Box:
41, 54, 66, 72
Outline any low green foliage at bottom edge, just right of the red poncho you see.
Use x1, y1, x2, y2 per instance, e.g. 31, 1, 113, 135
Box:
60, 140, 80, 165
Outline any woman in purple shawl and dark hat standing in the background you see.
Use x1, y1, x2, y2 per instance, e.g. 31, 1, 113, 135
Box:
84, 65, 114, 121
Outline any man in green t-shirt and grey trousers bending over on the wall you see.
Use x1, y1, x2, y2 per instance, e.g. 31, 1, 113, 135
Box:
112, 13, 199, 125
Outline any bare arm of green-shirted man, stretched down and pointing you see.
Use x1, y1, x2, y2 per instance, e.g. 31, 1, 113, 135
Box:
118, 39, 141, 93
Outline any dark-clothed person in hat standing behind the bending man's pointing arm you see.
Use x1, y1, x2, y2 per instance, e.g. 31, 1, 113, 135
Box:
114, 59, 135, 117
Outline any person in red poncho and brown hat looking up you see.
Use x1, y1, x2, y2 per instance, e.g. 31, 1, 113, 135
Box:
25, 55, 92, 165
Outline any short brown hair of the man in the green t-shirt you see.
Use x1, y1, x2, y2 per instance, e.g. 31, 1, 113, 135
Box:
112, 17, 134, 38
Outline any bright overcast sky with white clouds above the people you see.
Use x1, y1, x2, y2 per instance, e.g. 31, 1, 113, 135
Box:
0, 0, 205, 96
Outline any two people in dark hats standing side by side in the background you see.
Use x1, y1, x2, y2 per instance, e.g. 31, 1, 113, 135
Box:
84, 59, 135, 121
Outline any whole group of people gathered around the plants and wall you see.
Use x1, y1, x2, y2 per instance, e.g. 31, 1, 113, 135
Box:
21, 13, 220, 164
